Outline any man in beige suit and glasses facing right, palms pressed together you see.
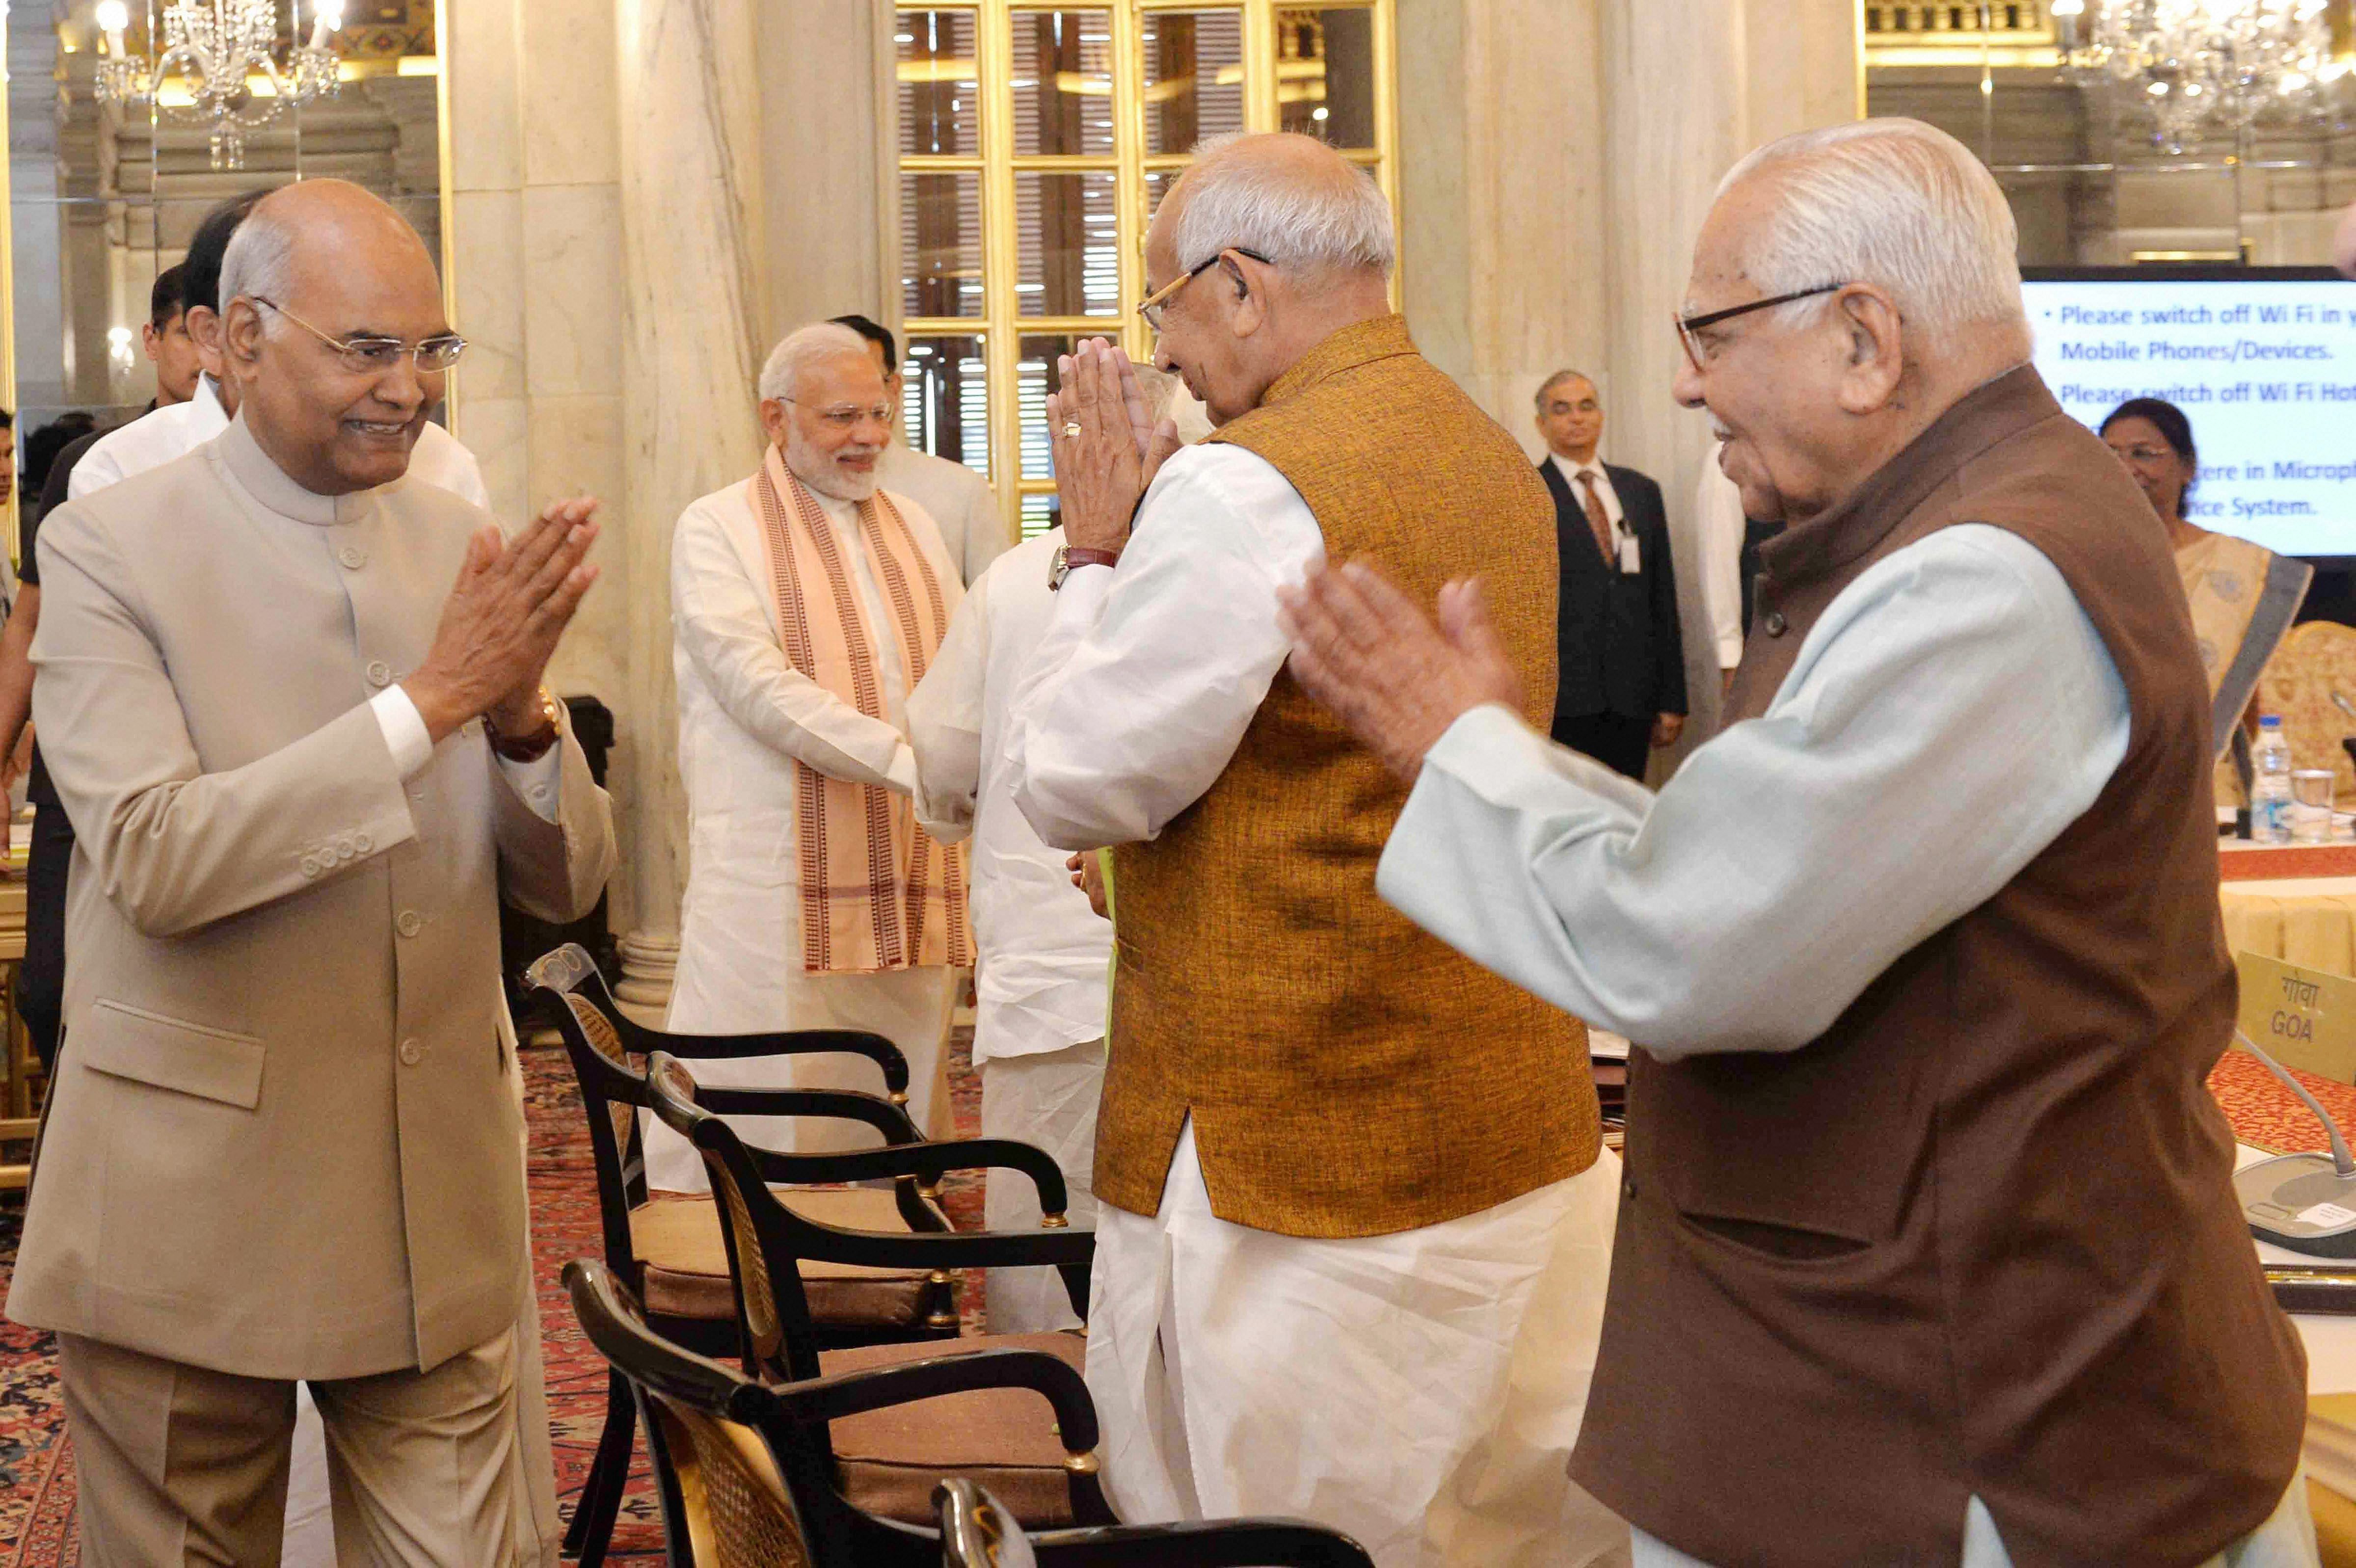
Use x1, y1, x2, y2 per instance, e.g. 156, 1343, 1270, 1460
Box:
7, 181, 613, 1563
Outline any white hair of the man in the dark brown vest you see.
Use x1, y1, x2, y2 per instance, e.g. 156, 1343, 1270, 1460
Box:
1717, 118, 2029, 342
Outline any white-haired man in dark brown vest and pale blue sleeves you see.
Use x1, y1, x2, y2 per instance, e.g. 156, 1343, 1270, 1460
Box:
1291, 120, 2316, 1568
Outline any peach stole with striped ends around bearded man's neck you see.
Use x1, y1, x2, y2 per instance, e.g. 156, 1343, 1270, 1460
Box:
751, 447, 973, 975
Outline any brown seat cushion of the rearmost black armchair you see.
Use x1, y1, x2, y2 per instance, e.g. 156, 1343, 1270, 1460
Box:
629, 1187, 947, 1328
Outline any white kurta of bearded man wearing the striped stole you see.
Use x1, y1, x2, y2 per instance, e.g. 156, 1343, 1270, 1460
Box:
645, 466, 959, 1191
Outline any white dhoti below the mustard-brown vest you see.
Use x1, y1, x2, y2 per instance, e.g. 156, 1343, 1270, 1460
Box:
1089, 1123, 1628, 1568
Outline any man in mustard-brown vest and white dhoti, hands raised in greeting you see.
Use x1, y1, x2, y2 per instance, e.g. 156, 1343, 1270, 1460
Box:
1006, 136, 1628, 1568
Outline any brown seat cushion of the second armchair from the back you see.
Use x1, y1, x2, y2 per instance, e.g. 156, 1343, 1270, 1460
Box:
818, 1332, 1089, 1530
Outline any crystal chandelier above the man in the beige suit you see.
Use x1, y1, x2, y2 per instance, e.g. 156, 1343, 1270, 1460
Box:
97, 0, 344, 169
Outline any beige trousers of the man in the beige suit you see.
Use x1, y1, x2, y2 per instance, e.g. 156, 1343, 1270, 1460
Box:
56, 1330, 528, 1568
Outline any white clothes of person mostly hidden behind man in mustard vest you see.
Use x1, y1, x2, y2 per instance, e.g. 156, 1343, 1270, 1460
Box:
907, 530, 1112, 1335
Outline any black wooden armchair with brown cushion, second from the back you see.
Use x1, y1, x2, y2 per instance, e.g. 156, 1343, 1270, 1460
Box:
645, 1036, 1114, 1528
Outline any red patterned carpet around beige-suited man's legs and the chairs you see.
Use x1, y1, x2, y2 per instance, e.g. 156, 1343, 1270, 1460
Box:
0, 1029, 983, 1568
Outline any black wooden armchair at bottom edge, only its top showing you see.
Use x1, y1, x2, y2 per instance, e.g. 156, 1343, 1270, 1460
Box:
933, 1481, 1373, 1568
